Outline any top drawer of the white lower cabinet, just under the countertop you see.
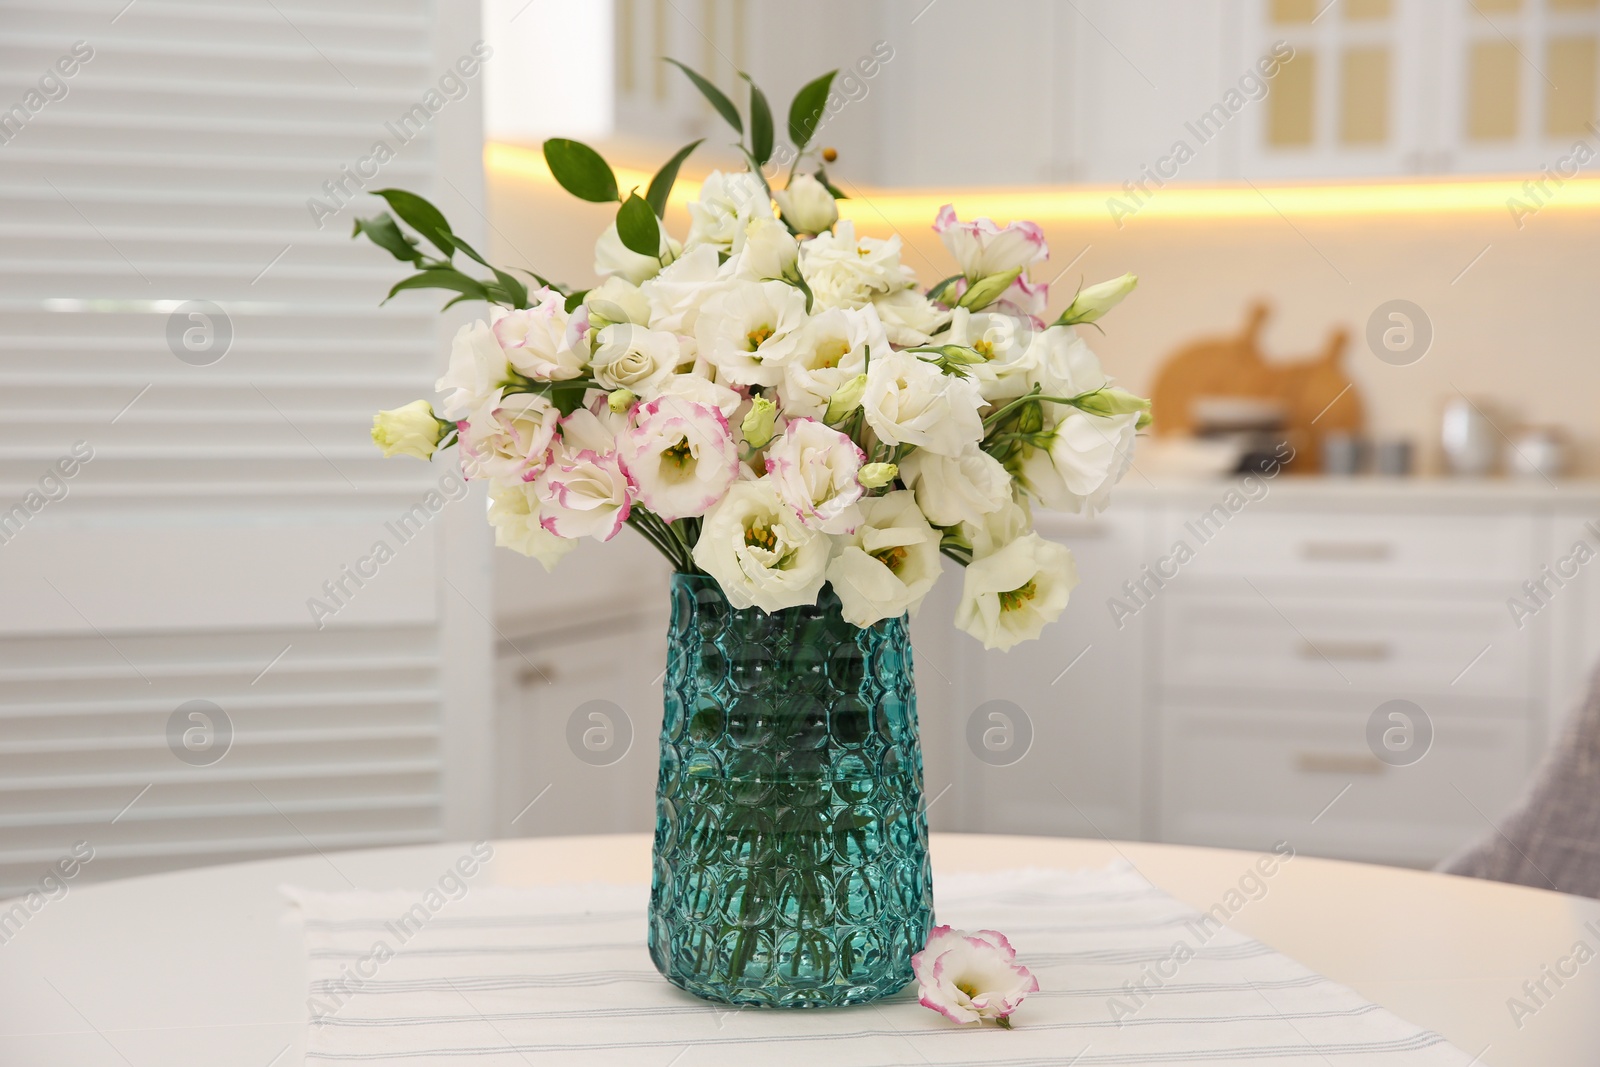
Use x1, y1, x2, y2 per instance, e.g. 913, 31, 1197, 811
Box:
1165, 507, 1533, 584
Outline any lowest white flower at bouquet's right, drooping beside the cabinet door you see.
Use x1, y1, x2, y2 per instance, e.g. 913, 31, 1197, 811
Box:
955, 533, 1078, 649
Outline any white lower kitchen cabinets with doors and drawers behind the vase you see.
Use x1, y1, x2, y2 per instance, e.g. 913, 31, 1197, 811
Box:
498, 477, 1600, 865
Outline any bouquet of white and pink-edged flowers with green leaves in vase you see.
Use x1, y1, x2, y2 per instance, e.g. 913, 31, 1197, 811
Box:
364, 69, 1149, 648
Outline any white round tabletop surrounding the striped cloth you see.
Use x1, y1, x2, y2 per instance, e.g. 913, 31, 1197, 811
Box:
0, 833, 1600, 1067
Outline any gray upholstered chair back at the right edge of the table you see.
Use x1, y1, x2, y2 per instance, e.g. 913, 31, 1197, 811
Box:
1438, 670, 1600, 897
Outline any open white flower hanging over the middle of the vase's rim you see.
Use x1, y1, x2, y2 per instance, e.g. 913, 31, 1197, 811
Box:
694, 478, 830, 613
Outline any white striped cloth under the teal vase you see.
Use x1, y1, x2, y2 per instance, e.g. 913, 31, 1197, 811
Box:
285, 864, 1470, 1067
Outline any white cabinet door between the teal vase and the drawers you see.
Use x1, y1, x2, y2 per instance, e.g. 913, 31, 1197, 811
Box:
955, 507, 1154, 838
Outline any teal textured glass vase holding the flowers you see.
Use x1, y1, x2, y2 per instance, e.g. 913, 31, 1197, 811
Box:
646, 574, 933, 1008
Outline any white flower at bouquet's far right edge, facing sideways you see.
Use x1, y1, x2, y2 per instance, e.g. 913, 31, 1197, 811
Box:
1018, 408, 1139, 515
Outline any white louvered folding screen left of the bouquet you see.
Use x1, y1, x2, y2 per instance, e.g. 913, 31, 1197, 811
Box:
0, 0, 493, 894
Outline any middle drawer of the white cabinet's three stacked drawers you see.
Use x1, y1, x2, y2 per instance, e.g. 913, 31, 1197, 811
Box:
1160, 593, 1530, 697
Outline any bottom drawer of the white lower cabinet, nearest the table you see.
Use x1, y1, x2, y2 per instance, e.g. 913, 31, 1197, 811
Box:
1162, 704, 1528, 864
